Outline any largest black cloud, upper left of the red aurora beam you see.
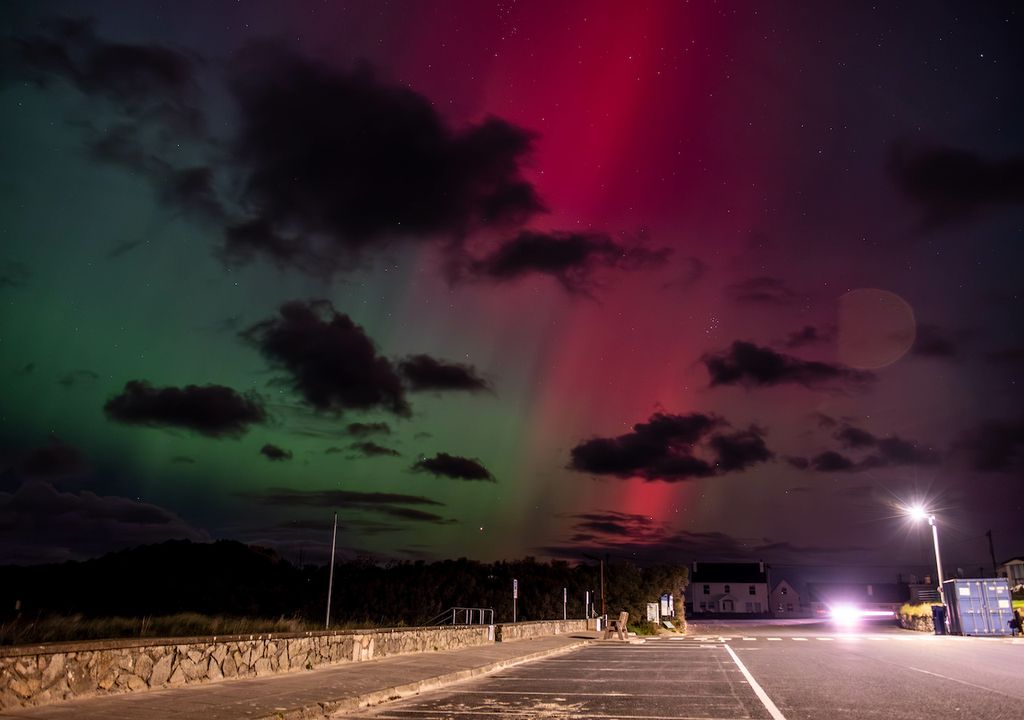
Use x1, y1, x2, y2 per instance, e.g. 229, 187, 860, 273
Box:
226, 44, 543, 272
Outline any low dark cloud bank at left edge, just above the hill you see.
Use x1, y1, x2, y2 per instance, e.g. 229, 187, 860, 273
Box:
0, 480, 210, 563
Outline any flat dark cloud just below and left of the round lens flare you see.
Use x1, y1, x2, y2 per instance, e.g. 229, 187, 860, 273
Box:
701, 340, 874, 388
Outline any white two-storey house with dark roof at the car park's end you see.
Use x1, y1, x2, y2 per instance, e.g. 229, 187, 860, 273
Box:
689, 562, 769, 616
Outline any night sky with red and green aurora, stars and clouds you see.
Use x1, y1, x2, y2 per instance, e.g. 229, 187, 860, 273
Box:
0, 0, 1024, 579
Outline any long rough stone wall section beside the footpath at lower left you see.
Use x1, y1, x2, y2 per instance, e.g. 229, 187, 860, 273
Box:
0, 621, 491, 711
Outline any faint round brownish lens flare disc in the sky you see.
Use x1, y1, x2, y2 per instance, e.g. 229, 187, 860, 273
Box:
839, 288, 916, 370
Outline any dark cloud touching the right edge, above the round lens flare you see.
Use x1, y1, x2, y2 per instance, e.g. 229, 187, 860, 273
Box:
889, 145, 1024, 227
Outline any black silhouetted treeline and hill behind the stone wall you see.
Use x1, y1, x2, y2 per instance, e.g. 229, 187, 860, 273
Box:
0, 540, 688, 627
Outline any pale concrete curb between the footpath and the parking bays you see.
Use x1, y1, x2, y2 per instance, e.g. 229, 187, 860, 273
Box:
264, 640, 593, 720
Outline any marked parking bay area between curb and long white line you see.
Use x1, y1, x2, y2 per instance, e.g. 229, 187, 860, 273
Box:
345, 639, 772, 720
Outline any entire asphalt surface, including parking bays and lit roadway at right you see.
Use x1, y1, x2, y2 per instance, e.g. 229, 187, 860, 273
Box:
346, 621, 1024, 720
